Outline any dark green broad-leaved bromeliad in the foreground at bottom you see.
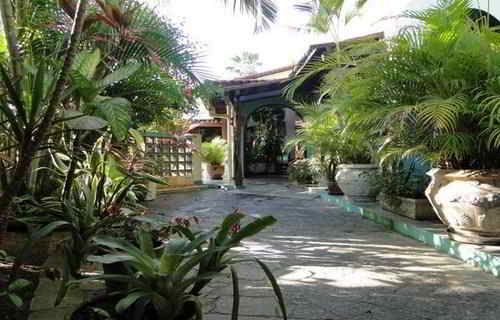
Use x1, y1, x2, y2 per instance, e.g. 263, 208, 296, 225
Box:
72, 210, 287, 320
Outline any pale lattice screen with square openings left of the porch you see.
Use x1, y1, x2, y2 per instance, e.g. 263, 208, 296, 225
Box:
144, 132, 193, 177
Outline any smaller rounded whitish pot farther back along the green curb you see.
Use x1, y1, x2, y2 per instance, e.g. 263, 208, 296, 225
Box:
335, 164, 379, 202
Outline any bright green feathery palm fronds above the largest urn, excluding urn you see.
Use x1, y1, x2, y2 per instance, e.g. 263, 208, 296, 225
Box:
312, 0, 500, 169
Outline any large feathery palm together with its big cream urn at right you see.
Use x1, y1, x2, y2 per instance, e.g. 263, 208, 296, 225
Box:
310, 0, 500, 244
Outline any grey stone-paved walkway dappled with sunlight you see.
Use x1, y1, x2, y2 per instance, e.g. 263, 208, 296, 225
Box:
150, 185, 500, 320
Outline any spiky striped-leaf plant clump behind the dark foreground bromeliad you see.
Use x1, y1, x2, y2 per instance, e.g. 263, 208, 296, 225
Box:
31, 135, 163, 304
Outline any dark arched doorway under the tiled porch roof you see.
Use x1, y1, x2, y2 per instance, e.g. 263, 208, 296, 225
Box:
243, 105, 301, 178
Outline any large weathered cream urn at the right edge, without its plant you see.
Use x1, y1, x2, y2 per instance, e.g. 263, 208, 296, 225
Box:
425, 169, 500, 244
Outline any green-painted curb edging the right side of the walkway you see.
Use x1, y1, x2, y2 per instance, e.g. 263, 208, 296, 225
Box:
320, 192, 500, 277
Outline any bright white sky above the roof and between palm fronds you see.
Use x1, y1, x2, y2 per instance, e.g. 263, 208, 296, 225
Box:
158, 0, 500, 79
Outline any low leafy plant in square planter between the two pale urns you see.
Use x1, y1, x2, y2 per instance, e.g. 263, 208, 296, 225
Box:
375, 161, 437, 220
